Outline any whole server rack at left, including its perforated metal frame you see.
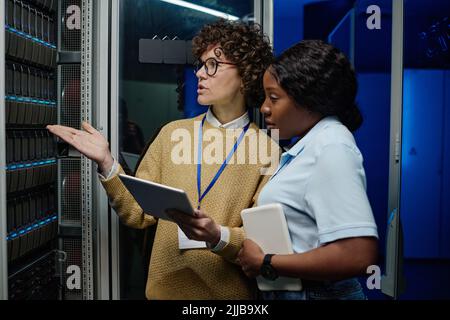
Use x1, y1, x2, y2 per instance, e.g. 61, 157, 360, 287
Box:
0, 0, 94, 300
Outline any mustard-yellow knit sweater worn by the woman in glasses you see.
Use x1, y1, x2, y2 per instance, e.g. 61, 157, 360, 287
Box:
102, 115, 279, 299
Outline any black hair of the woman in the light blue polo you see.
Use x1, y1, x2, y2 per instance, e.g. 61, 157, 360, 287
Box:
269, 40, 363, 131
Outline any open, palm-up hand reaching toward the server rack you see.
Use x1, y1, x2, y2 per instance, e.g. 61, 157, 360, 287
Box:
47, 122, 114, 173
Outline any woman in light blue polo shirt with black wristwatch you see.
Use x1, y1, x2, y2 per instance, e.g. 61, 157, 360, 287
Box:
239, 40, 378, 300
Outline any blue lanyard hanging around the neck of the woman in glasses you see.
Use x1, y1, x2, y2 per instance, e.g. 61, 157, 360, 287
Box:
197, 116, 250, 209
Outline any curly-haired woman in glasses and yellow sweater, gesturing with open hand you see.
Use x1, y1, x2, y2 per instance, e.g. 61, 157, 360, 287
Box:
48, 20, 278, 299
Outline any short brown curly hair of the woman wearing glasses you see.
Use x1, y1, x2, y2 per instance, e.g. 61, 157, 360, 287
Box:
192, 19, 273, 108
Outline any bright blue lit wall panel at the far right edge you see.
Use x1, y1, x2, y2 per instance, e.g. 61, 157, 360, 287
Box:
401, 70, 444, 258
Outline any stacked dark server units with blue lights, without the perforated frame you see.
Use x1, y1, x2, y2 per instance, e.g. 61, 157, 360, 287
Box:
1, 0, 59, 300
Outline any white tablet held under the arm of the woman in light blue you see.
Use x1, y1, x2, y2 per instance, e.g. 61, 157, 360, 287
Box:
241, 203, 302, 291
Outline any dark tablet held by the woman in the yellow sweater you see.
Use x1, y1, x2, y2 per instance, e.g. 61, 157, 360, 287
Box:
119, 174, 194, 221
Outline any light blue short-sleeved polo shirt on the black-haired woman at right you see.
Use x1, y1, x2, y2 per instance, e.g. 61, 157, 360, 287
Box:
258, 117, 378, 253
